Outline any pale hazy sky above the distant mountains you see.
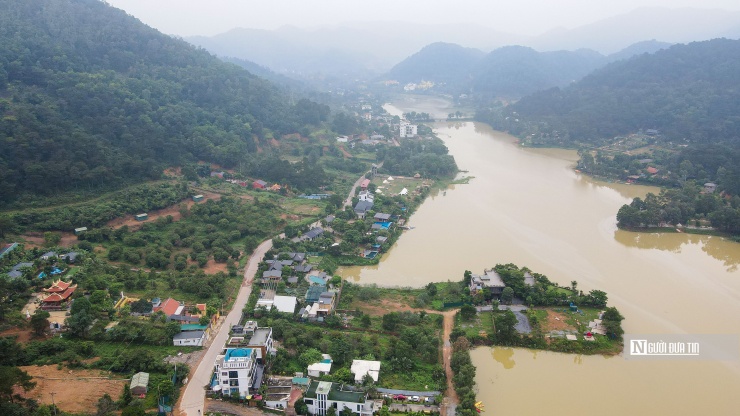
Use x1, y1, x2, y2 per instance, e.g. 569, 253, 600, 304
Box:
107, 0, 740, 36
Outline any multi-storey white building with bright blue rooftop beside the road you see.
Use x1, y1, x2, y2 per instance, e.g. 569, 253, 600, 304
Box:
213, 348, 262, 397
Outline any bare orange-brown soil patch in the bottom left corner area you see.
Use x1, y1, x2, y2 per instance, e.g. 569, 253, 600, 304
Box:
20, 365, 128, 414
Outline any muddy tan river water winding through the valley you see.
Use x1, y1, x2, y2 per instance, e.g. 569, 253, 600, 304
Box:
340, 98, 740, 416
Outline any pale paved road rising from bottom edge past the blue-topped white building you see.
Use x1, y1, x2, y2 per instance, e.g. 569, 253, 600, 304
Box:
176, 240, 272, 416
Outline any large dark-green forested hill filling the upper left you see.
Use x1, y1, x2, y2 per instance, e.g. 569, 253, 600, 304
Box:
0, 0, 328, 206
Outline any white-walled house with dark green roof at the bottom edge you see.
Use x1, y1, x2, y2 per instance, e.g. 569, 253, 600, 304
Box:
303, 380, 373, 416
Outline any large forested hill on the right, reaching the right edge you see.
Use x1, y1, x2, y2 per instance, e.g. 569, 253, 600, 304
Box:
479, 39, 740, 146
